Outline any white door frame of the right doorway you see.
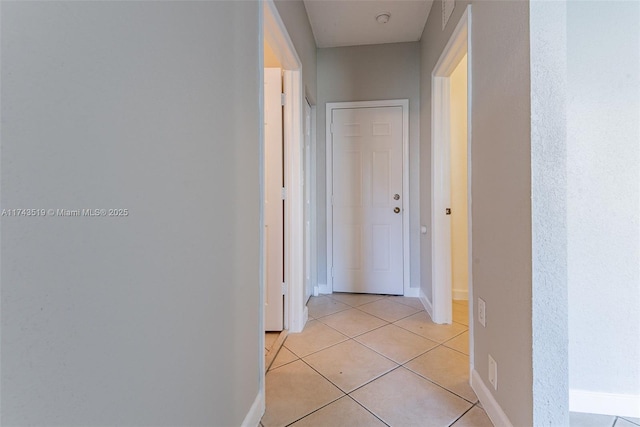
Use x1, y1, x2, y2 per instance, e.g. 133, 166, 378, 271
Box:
431, 6, 473, 328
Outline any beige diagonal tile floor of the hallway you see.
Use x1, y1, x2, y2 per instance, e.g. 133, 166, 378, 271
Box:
261, 293, 492, 427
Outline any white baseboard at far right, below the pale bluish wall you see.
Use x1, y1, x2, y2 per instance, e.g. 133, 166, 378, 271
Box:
569, 389, 640, 418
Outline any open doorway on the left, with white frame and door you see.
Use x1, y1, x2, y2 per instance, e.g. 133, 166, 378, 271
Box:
260, 1, 308, 386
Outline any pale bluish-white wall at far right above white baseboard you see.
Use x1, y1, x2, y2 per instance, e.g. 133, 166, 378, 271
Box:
567, 1, 640, 396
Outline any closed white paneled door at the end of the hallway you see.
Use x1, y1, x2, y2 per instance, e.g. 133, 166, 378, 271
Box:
331, 107, 404, 295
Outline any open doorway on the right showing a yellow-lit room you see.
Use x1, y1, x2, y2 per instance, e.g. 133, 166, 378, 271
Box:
431, 6, 473, 336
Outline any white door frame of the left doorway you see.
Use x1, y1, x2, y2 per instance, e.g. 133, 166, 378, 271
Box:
260, 0, 308, 334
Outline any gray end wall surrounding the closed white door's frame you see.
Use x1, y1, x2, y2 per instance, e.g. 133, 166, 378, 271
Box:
317, 42, 420, 288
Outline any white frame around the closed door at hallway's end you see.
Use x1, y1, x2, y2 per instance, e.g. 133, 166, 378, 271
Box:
323, 99, 415, 296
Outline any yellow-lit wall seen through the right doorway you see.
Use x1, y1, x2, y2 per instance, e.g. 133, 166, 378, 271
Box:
449, 55, 469, 300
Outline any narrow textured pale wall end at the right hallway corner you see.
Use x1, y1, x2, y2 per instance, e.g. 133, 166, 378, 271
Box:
530, 0, 569, 426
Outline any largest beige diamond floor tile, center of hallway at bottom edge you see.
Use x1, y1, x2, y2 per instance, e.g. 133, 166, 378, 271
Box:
351, 367, 472, 427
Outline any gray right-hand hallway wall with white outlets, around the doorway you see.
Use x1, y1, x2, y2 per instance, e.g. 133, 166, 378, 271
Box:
420, 1, 533, 425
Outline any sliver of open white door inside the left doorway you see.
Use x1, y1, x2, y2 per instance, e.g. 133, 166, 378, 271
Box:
264, 68, 284, 331
